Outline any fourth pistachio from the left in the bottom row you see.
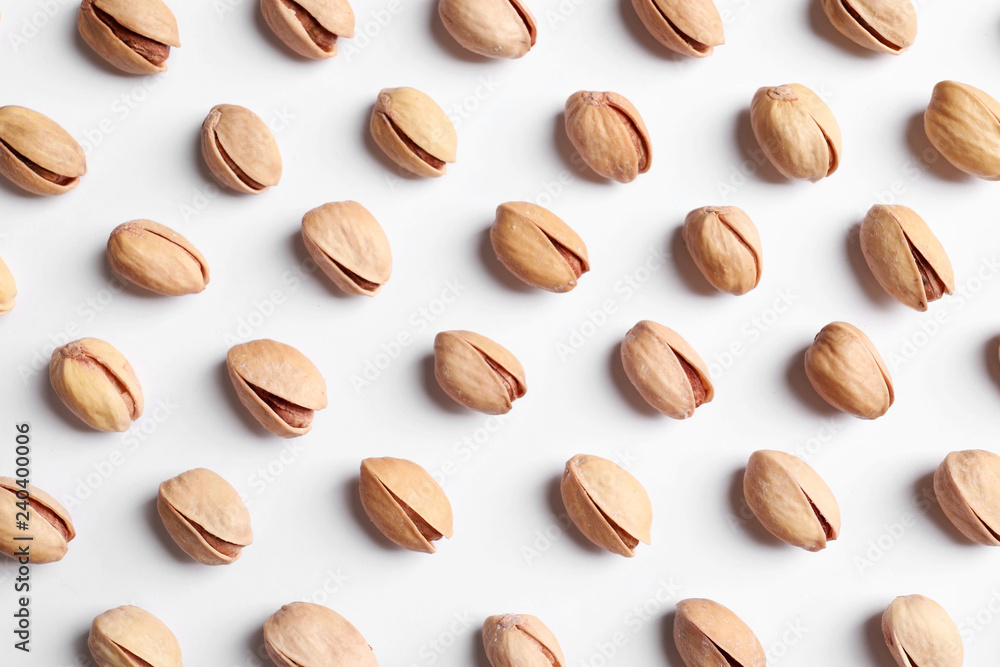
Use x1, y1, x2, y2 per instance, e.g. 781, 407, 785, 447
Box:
674, 598, 767, 667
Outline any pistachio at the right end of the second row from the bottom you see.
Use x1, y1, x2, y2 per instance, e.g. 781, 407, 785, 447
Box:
934, 449, 1000, 547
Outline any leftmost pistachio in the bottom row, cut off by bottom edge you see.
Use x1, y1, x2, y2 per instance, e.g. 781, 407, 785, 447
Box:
87, 605, 182, 667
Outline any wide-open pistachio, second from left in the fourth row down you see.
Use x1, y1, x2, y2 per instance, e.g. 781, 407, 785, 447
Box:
226, 338, 326, 438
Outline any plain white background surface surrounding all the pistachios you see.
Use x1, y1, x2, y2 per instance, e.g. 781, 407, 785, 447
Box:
0, 0, 1000, 667
